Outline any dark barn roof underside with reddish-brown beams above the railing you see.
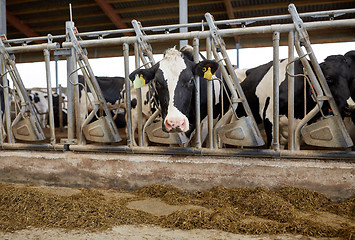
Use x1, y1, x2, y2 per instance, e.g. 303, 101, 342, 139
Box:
6, 0, 355, 62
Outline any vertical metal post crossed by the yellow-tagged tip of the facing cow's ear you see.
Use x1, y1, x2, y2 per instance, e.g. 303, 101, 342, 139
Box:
206, 37, 217, 149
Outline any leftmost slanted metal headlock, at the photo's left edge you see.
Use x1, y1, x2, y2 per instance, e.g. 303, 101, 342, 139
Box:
0, 35, 45, 141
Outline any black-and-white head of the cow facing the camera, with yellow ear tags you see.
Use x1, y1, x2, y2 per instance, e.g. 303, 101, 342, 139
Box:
129, 46, 218, 132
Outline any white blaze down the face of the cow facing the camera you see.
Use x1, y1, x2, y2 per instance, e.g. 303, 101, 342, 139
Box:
160, 49, 189, 132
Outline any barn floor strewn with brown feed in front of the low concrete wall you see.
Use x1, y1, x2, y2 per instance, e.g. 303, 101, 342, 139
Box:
0, 183, 355, 240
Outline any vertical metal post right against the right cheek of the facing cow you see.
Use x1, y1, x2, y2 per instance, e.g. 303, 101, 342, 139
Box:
193, 38, 201, 148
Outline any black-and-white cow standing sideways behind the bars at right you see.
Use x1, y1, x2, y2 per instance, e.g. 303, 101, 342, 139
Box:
237, 51, 355, 147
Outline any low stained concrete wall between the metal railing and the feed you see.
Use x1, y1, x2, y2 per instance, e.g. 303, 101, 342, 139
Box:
0, 150, 355, 200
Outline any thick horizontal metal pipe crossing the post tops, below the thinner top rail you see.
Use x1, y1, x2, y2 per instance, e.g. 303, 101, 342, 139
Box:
62, 19, 355, 48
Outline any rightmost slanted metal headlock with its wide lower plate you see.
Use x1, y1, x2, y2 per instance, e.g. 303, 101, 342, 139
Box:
288, 4, 353, 149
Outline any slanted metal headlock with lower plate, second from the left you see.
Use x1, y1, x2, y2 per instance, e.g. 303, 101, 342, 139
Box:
67, 22, 122, 142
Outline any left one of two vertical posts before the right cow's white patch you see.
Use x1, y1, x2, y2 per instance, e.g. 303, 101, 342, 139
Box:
272, 32, 280, 151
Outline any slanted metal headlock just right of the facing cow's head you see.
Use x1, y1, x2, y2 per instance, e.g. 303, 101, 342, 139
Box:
205, 13, 264, 147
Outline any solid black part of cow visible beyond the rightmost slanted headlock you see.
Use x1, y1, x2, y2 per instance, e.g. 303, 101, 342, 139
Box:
320, 55, 353, 114
